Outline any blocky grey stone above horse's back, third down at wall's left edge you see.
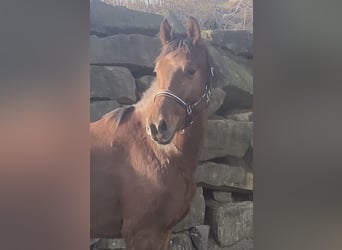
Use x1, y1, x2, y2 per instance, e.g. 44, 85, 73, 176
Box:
90, 66, 136, 104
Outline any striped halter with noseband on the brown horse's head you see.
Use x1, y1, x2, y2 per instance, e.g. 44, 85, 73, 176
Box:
154, 67, 214, 128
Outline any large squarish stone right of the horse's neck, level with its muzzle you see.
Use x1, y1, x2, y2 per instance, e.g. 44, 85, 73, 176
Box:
200, 119, 253, 161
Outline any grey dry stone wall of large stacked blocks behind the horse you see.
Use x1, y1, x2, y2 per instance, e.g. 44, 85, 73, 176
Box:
90, 0, 253, 250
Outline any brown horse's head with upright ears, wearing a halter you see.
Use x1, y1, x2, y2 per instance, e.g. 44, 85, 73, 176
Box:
146, 17, 210, 144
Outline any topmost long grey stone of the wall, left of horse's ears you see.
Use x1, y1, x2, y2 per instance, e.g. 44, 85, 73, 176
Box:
90, 0, 163, 36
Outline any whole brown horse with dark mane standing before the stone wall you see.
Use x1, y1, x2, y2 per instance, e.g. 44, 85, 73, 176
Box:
90, 17, 211, 250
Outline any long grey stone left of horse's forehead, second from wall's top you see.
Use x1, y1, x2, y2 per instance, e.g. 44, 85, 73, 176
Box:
90, 34, 161, 70
